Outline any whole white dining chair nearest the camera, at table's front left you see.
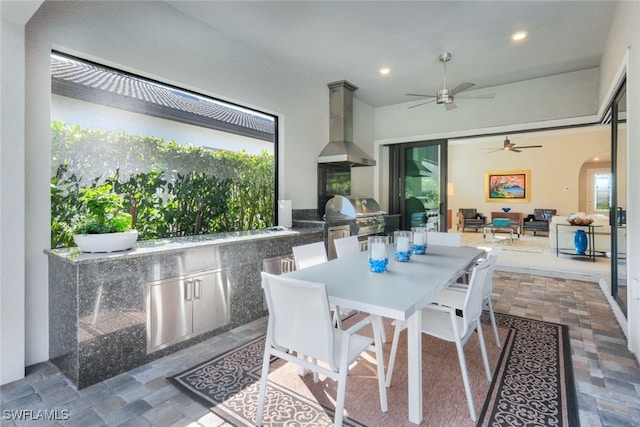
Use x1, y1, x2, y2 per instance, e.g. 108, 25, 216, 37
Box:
256, 272, 387, 426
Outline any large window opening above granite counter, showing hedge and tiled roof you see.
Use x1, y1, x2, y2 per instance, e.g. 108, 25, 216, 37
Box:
51, 52, 278, 248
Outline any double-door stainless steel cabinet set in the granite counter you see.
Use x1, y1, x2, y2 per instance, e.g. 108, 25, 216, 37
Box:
147, 268, 231, 353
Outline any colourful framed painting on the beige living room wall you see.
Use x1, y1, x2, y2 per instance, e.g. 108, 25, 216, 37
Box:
485, 170, 531, 203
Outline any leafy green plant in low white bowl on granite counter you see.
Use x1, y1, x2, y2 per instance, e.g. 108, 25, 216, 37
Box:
73, 184, 138, 252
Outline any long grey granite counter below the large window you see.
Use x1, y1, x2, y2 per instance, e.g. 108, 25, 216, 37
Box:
45, 228, 323, 388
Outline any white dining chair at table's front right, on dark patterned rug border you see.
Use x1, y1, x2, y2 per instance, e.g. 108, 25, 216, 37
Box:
386, 263, 492, 421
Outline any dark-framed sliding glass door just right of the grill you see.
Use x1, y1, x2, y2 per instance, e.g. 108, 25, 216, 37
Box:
389, 140, 447, 231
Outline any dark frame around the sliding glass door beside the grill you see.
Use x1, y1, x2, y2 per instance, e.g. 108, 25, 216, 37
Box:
389, 139, 448, 232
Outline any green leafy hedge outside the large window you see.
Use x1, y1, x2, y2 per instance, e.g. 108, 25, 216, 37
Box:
51, 121, 275, 248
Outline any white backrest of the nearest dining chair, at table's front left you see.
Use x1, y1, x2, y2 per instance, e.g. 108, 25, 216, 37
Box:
261, 272, 338, 371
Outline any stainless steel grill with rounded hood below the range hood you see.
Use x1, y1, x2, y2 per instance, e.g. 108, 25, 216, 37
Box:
325, 196, 384, 237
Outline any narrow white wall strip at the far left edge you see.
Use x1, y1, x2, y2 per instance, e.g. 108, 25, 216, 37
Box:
0, 5, 26, 384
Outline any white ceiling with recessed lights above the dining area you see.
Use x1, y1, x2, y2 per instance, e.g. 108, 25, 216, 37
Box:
167, 0, 616, 107
